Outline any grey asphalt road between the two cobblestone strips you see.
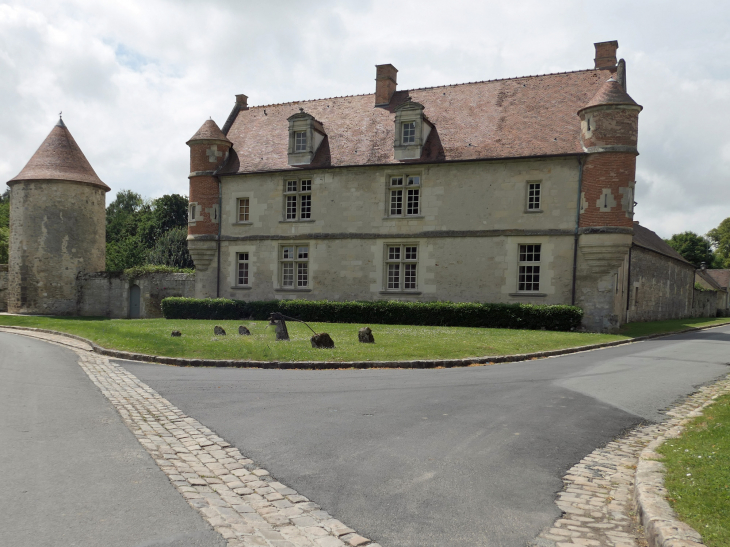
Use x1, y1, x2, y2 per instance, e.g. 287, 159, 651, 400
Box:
117, 327, 730, 547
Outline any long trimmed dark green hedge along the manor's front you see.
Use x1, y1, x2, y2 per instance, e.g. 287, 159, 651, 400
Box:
162, 297, 583, 331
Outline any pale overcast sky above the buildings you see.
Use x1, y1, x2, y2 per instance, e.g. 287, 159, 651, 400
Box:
0, 0, 730, 237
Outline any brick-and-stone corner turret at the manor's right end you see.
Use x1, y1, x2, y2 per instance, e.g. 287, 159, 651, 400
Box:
576, 76, 642, 332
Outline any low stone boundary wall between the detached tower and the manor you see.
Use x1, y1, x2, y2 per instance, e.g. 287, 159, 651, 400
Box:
76, 272, 195, 319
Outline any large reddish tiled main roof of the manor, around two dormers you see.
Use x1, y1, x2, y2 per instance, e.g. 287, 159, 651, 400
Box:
221, 70, 612, 174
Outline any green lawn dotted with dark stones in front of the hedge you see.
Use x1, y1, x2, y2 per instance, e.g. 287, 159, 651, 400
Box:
0, 315, 624, 361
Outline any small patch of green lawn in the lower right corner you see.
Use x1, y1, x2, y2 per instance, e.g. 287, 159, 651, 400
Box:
659, 395, 730, 547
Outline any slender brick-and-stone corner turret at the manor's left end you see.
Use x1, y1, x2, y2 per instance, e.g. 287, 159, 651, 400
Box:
187, 120, 233, 296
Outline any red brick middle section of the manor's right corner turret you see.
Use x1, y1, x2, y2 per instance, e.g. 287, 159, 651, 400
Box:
580, 152, 636, 228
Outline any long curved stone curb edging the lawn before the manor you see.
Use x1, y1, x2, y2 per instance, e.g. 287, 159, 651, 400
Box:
0, 322, 730, 370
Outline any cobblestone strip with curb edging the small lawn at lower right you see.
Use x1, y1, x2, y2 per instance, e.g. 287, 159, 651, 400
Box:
531, 375, 730, 547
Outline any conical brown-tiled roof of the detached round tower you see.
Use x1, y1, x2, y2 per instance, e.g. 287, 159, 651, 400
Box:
8, 119, 111, 192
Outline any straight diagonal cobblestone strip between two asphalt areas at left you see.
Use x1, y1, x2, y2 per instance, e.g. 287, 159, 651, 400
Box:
0, 329, 380, 547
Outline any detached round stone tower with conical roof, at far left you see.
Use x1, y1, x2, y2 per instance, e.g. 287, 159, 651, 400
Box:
8, 119, 110, 315
